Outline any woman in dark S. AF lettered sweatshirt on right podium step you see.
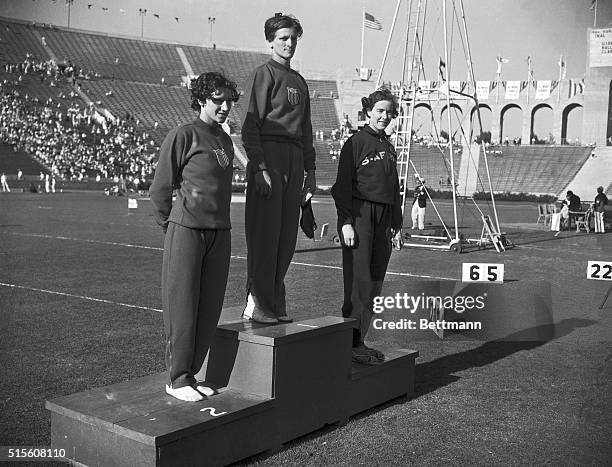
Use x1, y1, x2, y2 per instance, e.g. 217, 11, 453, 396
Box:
332, 89, 402, 365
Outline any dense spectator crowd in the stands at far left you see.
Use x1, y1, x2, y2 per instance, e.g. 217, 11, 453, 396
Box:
0, 89, 158, 185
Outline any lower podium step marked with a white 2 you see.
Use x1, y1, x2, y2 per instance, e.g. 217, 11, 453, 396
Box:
46, 373, 279, 467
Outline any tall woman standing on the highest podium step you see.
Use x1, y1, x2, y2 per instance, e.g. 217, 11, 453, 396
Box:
242, 13, 317, 324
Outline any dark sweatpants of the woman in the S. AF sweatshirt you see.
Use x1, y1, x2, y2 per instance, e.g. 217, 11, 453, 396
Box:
338, 198, 392, 347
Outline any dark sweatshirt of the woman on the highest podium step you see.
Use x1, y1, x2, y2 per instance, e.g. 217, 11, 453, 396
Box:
242, 60, 316, 170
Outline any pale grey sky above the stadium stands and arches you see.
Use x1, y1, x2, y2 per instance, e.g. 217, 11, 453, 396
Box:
0, 0, 612, 81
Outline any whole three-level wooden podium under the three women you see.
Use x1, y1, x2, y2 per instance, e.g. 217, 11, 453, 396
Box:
46, 316, 418, 466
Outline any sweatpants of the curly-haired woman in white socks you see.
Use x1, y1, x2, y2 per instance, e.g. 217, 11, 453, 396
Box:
162, 222, 231, 389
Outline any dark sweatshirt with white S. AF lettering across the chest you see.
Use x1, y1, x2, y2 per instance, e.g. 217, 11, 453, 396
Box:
332, 125, 402, 230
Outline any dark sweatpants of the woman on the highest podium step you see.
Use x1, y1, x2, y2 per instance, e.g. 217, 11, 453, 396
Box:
245, 141, 304, 316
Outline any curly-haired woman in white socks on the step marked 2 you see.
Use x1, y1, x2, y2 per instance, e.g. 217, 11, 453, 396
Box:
149, 72, 238, 401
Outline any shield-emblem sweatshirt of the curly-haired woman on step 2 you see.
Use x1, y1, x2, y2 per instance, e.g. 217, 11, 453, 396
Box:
149, 118, 234, 230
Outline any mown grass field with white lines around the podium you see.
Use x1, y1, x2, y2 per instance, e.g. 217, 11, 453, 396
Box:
0, 193, 612, 465
